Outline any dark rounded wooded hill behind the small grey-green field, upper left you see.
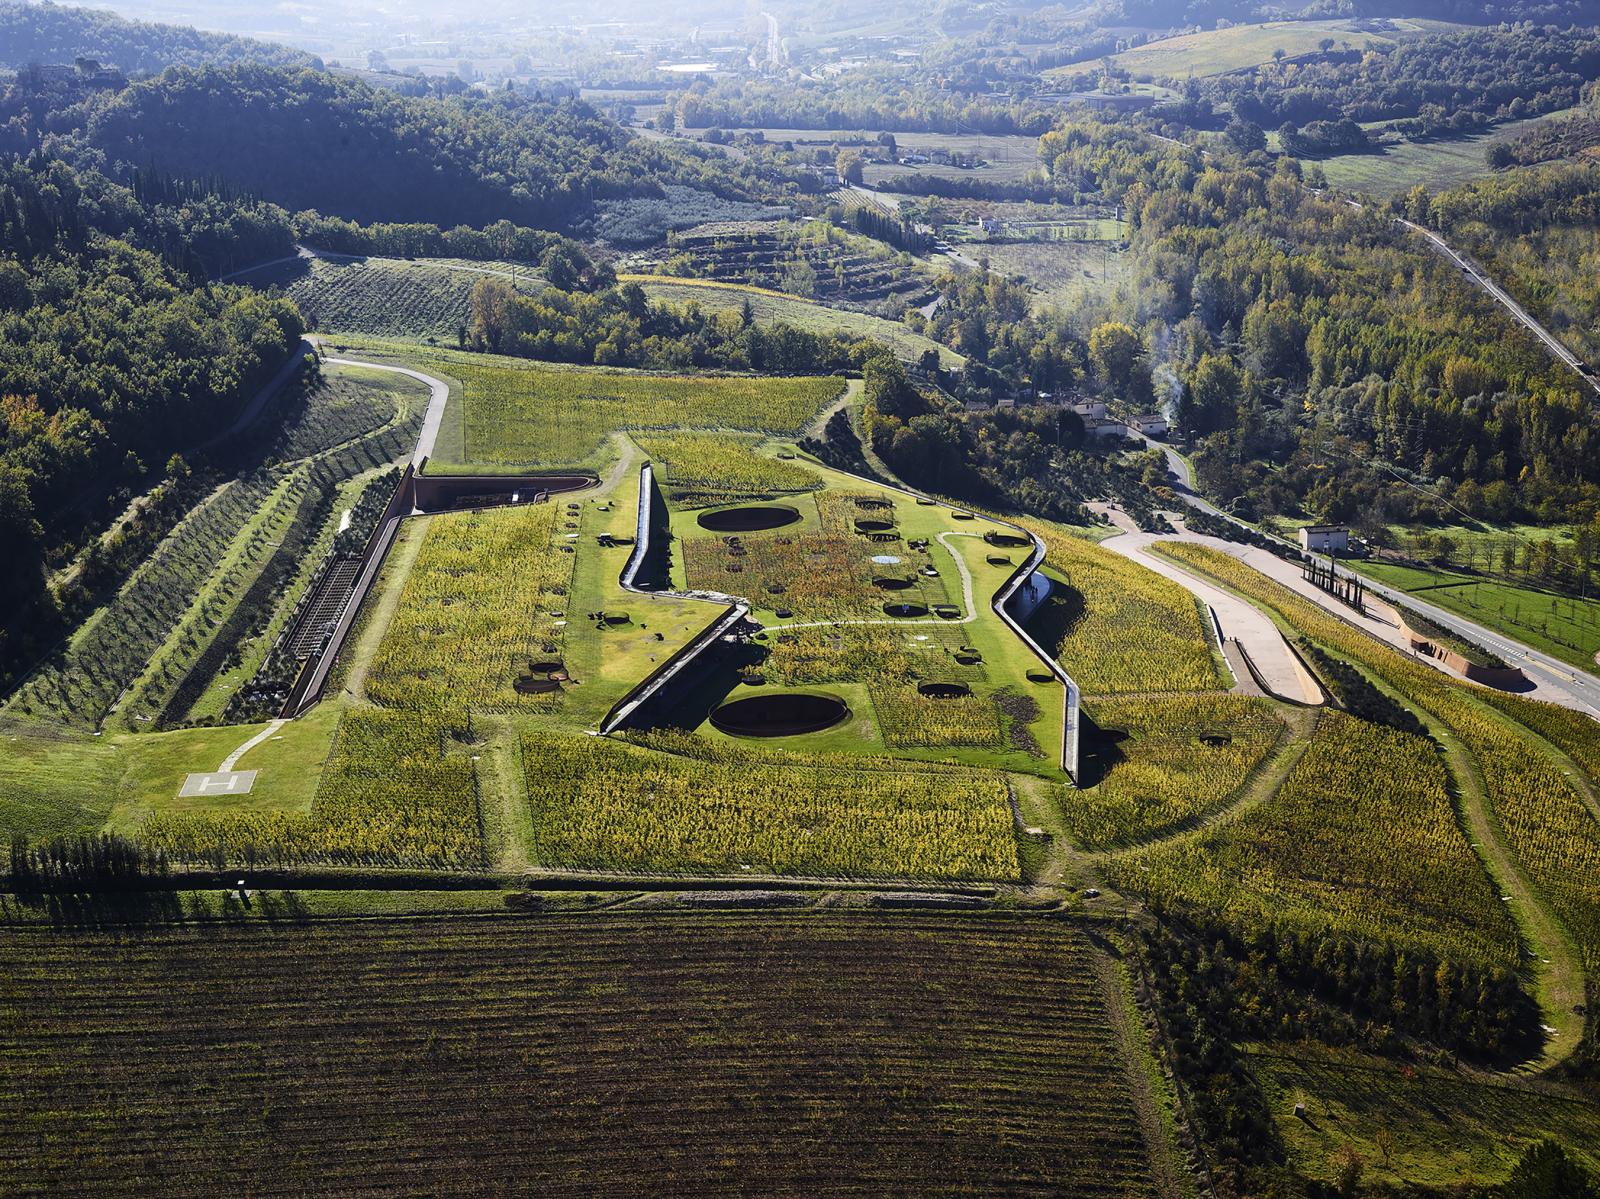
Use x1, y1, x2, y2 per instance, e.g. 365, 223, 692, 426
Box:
65, 66, 784, 229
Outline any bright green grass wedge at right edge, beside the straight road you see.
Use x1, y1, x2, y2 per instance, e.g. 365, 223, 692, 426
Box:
1358, 562, 1600, 669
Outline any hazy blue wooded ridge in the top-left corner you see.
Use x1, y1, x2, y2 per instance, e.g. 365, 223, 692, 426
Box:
0, 3, 322, 75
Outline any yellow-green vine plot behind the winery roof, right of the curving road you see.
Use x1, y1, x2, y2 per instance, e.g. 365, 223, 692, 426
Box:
427, 345, 845, 474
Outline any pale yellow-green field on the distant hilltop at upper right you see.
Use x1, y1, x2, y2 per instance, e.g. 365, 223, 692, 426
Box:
1075, 18, 1454, 80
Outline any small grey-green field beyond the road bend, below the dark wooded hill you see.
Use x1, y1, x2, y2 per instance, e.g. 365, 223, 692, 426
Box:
240, 255, 544, 344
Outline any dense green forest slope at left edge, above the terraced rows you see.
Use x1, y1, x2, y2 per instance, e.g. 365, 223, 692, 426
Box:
0, 160, 301, 677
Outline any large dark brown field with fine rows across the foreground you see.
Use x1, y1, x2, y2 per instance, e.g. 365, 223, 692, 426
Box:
0, 912, 1177, 1199
